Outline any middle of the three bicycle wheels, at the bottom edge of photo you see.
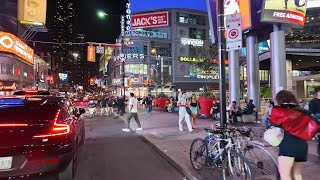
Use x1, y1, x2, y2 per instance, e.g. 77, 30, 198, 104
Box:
222, 150, 254, 180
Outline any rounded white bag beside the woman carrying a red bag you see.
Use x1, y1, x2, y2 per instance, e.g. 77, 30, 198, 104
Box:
263, 126, 284, 146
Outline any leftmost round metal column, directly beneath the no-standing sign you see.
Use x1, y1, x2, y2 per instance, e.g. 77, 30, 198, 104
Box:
228, 50, 240, 105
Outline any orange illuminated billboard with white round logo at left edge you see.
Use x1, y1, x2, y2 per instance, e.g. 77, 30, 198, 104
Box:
0, 31, 34, 64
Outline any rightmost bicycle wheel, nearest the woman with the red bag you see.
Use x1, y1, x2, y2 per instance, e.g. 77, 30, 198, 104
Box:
244, 144, 280, 180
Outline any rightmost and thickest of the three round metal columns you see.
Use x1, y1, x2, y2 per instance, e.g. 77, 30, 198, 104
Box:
270, 25, 287, 98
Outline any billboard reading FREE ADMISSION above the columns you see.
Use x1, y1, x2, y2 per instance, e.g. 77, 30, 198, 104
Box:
261, 0, 307, 27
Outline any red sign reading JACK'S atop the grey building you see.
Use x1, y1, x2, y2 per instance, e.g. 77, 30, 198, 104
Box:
131, 11, 169, 28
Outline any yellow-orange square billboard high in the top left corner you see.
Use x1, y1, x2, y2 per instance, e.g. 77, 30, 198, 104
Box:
18, 0, 47, 25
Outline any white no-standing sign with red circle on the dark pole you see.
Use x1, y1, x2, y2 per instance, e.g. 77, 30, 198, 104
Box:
226, 13, 242, 51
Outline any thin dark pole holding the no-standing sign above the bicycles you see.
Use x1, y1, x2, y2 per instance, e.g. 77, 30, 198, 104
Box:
218, 0, 227, 127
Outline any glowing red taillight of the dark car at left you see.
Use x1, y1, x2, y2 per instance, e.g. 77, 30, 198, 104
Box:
33, 109, 71, 138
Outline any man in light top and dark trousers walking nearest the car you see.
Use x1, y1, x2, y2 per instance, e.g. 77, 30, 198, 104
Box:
122, 93, 142, 132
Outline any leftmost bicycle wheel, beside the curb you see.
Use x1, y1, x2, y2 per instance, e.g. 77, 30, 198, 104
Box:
189, 138, 208, 171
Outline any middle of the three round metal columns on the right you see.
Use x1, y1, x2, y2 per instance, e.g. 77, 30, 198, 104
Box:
246, 34, 260, 112
